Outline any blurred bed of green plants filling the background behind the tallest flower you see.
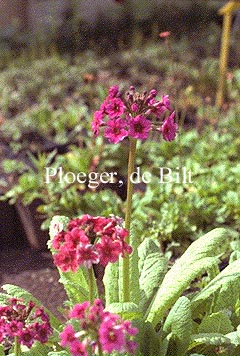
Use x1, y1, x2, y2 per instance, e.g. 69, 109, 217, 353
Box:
0, 0, 240, 253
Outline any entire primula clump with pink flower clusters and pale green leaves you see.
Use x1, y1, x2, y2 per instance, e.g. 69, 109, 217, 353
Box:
0, 86, 240, 356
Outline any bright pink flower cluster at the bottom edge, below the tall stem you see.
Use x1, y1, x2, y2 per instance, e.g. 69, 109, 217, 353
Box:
60, 299, 138, 356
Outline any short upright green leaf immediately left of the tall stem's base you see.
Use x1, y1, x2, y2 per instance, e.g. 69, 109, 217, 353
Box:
103, 262, 119, 307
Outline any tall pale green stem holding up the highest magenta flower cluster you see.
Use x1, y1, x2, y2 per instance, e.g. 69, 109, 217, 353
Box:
122, 137, 137, 302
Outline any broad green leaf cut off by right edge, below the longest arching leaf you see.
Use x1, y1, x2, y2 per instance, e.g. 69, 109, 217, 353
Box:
191, 260, 240, 315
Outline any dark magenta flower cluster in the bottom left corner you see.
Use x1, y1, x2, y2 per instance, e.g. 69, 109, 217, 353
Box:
0, 298, 52, 348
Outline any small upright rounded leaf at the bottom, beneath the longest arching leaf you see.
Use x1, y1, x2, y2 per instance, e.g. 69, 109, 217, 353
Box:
163, 297, 192, 355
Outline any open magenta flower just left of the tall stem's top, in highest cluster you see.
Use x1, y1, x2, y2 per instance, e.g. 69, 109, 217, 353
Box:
104, 118, 128, 143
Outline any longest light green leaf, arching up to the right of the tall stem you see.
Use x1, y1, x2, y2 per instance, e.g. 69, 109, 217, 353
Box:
147, 228, 229, 326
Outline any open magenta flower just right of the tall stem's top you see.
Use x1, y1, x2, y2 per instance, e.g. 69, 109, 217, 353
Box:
129, 115, 151, 140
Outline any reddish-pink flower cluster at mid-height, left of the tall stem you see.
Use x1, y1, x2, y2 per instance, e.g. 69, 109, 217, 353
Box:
52, 215, 132, 272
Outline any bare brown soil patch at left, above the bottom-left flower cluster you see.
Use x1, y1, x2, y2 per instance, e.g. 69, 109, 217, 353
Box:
0, 240, 66, 317
